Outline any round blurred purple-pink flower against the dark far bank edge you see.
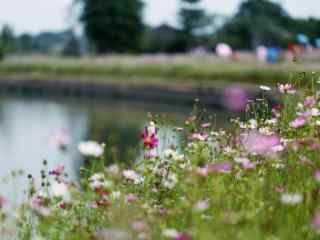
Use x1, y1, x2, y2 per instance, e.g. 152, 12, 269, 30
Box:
224, 86, 249, 112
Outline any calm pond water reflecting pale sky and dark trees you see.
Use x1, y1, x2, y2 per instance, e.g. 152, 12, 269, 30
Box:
0, 96, 230, 204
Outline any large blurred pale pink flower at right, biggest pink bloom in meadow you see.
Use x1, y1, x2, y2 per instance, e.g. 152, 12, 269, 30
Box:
242, 131, 281, 155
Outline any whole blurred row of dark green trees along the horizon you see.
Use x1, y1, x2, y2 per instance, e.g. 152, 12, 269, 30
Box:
0, 0, 320, 58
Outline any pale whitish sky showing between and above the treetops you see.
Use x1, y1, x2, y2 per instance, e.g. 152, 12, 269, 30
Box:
0, 0, 320, 33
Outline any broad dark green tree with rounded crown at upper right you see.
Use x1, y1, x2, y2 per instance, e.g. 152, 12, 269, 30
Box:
214, 0, 320, 49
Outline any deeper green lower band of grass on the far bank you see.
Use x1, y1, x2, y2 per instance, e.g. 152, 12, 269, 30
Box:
0, 62, 295, 86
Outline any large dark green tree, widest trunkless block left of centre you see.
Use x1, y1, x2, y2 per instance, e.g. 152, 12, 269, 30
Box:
81, 0, 144, 53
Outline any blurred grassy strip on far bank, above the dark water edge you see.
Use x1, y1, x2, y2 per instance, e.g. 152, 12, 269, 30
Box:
0, 56, 320, 86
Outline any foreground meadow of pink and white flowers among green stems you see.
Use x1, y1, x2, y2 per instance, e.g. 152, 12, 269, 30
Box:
0, 74, 320, 240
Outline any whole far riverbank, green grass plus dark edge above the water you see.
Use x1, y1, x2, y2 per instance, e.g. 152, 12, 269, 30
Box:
0, 56, 319, 108
